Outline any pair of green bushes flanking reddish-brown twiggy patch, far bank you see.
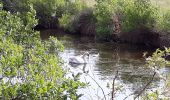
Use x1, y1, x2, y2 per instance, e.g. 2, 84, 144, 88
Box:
94, 0, 157, 38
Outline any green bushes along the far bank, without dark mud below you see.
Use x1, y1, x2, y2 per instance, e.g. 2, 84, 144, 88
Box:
3, 0, 170, 38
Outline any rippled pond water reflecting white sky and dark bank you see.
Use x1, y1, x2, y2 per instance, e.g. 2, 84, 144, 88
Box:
41, 30, 170, 100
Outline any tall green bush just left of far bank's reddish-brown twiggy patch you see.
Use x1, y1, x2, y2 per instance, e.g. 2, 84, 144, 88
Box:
94, 0, 116, 38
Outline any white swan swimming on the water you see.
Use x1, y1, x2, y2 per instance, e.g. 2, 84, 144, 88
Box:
69, 52, 89, 64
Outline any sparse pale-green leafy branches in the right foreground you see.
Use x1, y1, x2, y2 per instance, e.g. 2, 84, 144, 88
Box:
143, 48, 170, 100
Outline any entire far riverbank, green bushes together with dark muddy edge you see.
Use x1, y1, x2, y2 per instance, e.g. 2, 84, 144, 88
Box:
3, 0, 170, 47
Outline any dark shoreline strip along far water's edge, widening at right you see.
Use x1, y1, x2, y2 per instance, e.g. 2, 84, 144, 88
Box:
35, 28, 170, 49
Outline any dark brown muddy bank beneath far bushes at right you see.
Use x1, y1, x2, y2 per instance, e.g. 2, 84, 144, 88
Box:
86, 30, 170, 49
